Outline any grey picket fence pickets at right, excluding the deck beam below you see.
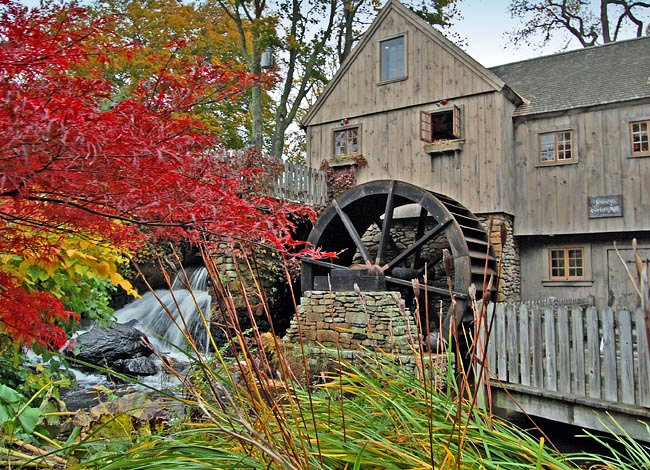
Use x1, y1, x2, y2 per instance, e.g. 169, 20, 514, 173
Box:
487, 303, 650, 408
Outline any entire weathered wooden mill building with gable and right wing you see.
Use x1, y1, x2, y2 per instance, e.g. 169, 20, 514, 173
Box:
303, 0, 650, 309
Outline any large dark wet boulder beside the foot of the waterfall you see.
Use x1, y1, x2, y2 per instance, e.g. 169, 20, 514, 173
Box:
76, 325, 151, 368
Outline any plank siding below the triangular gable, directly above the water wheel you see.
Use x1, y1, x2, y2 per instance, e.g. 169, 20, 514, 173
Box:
307, 93, 516, 213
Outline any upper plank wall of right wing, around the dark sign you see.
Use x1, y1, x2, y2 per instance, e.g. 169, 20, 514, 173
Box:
514, 103, 650, 235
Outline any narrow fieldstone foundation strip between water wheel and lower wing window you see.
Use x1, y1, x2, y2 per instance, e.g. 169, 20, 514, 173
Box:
477, 213, 521, 302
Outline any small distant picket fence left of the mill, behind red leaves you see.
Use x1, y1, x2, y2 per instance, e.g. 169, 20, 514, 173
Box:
273, 161, 327, 206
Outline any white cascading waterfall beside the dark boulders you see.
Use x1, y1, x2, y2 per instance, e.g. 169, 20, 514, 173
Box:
114, 267, 212, 357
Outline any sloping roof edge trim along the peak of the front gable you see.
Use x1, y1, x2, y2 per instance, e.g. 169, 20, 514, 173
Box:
302, 0, 522, 126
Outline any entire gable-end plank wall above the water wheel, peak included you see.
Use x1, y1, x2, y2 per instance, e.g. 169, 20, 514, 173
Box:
307, 0, 514, 213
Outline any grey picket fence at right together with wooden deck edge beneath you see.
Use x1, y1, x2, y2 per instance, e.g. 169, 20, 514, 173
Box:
487, 304, 650, 441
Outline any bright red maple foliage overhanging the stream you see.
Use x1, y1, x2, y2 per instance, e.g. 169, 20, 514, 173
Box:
0, 0, 312, 347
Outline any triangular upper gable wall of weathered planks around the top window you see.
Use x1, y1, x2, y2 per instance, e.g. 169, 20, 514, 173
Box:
308, 8, 498, 125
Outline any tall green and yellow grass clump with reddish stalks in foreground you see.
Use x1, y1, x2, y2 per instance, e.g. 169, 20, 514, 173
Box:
62, 246, 588, 469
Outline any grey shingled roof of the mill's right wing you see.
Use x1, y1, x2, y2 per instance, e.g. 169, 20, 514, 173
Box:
490, 36, 650, 116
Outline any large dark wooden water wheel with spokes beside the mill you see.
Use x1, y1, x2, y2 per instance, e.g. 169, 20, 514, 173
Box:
301, 180, 496, 334
